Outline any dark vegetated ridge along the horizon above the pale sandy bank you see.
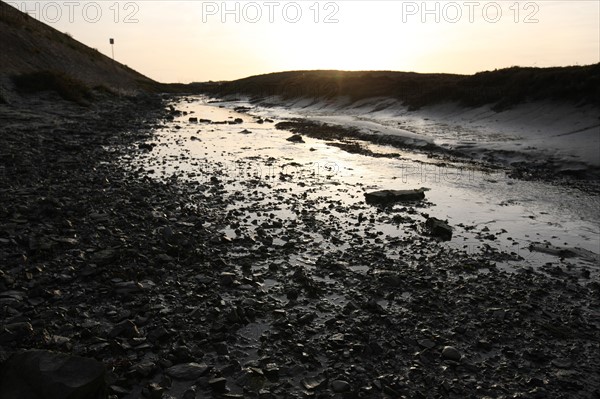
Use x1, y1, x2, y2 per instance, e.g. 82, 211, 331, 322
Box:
197, 64, 600, 111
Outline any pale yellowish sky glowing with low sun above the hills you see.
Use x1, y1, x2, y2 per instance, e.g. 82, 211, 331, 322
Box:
3, 0, 600, 83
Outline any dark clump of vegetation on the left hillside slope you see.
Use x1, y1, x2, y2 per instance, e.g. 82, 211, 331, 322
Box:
12, 71, 93, 105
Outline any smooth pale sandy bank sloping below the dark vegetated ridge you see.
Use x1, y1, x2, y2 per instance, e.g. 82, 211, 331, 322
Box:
250, 98, 600, 171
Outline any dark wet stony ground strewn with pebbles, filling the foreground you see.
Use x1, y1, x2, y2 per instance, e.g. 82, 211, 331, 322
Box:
0, 94, 600, 398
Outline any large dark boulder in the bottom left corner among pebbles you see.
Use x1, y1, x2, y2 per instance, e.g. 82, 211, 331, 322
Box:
0, 350, 108, 399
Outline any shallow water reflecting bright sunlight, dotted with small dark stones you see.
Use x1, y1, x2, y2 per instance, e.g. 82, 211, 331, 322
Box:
124, 97, 600, 278
